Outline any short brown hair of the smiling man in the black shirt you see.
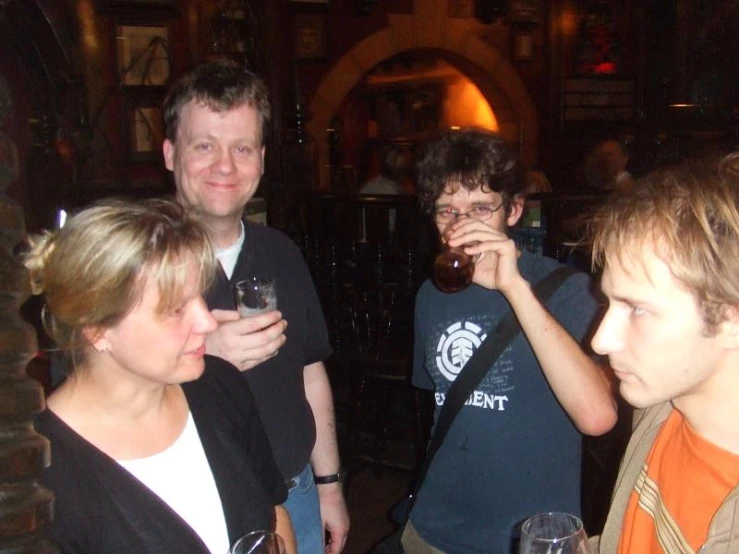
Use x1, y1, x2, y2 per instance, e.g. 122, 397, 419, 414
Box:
164, 58, 270, 142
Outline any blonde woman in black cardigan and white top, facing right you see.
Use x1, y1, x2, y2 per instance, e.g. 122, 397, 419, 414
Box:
25, 201, 295, 554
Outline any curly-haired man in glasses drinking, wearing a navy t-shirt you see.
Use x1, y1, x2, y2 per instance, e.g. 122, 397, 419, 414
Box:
402, 130, 616, 554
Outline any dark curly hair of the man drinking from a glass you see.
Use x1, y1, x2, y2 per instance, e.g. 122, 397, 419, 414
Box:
416, 129, 525, 215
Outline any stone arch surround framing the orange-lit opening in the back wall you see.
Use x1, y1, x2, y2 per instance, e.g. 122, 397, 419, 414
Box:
308, 0, 539, 189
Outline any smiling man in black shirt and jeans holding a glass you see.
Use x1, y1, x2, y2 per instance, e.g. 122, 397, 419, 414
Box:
163, 60, 349, 554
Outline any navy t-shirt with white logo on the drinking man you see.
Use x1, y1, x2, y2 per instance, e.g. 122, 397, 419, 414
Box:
410, 252, 597, 554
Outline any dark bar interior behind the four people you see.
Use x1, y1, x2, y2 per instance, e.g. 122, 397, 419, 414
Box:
0, 0, 739, 554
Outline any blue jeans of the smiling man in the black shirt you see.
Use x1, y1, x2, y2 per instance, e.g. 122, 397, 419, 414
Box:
284, 464, 324, 554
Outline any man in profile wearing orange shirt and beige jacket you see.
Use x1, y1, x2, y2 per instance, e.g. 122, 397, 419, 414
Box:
591, 154, 739, 554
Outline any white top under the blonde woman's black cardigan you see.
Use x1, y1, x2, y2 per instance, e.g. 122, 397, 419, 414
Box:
117, 414, 230, 554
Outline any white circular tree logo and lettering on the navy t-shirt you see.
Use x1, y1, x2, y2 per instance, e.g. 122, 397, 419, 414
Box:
434, 321, 514, 411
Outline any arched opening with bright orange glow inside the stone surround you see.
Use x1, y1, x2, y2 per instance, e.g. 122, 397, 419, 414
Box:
330, 50, 500, 193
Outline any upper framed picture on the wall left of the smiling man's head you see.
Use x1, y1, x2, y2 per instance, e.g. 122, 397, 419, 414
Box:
116, 25, 170, 86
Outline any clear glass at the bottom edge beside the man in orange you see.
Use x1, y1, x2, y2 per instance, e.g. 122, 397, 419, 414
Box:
519, 512, 590, 554
